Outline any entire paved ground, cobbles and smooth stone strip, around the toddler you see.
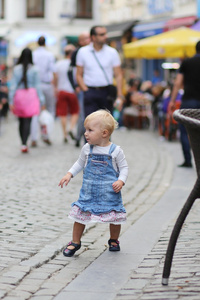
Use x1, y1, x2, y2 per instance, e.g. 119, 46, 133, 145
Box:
0, 117, 200, 300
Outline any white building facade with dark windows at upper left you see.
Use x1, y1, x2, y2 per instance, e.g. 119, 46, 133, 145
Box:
0, 0, 99, 65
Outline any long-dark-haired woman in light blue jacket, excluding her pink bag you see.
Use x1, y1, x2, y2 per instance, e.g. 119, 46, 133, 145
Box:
9, 48, 45, 153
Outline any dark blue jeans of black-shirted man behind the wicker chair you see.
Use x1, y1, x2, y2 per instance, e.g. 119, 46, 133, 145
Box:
179, 99, 200, 164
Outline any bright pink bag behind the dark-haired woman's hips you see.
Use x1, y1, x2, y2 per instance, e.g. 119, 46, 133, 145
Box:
13, 88, 40, 118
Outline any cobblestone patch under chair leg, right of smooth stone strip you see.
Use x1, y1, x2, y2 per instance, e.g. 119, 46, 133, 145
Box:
115, 200, 200, 300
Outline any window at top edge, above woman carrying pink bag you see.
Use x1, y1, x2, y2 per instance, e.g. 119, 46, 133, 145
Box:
27, 0, 44, 18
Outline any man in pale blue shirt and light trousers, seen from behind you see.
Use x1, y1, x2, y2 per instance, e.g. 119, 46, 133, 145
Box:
31, 36, 56, 147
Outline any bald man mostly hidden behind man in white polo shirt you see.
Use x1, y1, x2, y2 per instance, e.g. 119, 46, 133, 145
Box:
68, 32, 90, 147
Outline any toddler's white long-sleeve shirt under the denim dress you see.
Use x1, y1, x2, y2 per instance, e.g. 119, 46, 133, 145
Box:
68, 143, 128, 183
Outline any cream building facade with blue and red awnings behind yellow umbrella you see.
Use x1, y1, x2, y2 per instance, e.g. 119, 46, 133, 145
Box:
100, 0, 197, 80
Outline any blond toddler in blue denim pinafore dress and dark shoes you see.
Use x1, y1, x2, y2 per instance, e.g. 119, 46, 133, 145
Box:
59, 110, 128, 256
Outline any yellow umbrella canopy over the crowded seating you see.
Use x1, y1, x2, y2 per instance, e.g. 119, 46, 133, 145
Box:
123, 27, 200, 59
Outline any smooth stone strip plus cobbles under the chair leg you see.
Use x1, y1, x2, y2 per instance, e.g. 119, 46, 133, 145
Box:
55, 137, 200, 300
